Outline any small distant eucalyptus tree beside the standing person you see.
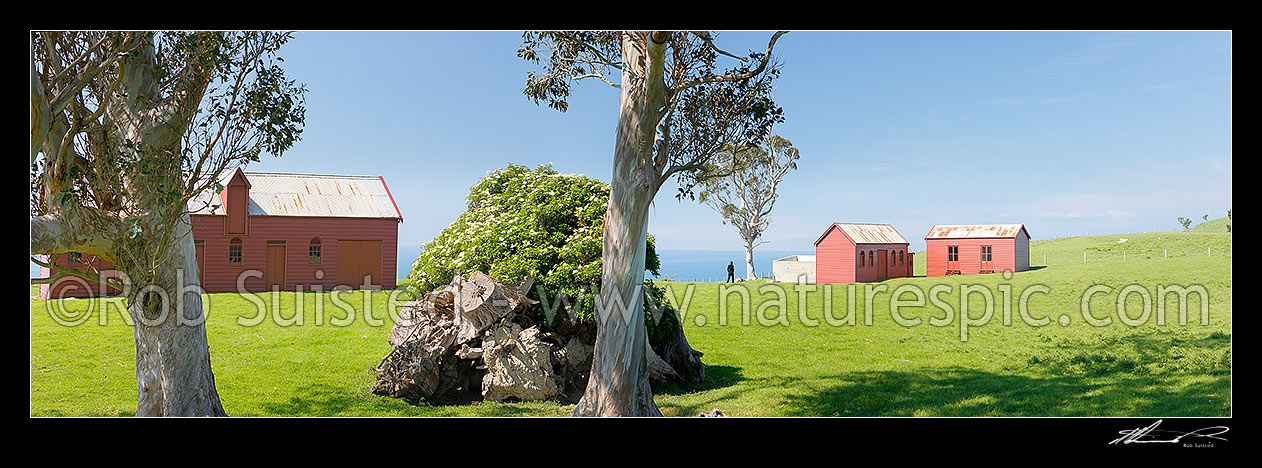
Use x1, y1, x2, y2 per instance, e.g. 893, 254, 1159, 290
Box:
697, 135, 799, 280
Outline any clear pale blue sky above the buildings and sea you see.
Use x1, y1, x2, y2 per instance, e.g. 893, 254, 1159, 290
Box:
238, 32, 1232, 252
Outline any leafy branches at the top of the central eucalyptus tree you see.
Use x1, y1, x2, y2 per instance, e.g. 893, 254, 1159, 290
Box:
517, 30, 787, 199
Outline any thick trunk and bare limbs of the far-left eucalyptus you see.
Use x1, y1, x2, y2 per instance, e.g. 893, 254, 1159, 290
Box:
30, 35, 226, 416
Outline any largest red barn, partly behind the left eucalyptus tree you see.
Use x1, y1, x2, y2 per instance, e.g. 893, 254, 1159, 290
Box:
39, 169, 403, 299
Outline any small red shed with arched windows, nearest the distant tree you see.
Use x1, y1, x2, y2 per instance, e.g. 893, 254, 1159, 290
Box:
815, 223, 912, 284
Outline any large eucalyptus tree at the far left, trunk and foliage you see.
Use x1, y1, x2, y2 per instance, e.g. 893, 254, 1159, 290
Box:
30, 32, 305, 416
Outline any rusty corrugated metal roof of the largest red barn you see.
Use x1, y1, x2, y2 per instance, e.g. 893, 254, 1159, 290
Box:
188, 173, 403, 219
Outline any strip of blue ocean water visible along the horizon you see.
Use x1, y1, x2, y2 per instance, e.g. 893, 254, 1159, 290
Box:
30, 246, 815, 281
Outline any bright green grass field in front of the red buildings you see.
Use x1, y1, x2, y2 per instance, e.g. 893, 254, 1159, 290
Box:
30, 232, 1232, 416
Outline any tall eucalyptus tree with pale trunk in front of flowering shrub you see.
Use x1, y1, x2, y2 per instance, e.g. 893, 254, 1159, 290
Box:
517, 30, 786, 416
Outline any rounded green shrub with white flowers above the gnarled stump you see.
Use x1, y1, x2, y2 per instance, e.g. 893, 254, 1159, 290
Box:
408, 164, 678, 329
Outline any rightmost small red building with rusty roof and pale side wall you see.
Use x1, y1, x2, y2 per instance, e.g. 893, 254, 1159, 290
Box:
925, 225, 1030, 276
